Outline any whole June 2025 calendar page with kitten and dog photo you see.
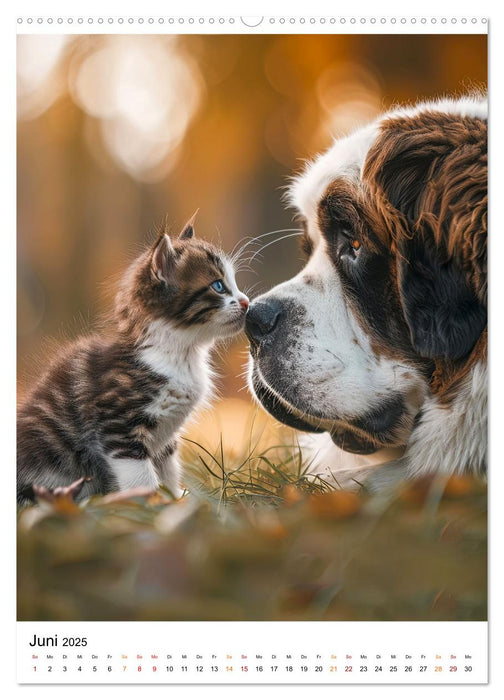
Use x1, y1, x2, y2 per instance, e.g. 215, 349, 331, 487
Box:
13, 5, 488, 692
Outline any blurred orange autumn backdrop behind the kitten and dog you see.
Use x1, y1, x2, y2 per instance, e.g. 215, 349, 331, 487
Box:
18, 35, 487, 400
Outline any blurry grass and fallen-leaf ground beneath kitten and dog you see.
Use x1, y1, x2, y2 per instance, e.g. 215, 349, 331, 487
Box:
18, 404, 486, 620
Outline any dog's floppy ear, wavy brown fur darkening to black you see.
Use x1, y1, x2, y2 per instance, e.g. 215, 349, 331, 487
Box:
363, 112, 487, 360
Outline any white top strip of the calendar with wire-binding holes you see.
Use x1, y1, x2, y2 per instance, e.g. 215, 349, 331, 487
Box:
9, 0, 488, 34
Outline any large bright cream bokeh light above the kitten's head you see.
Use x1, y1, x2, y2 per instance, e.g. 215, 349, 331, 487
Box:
70, 36, 203, 181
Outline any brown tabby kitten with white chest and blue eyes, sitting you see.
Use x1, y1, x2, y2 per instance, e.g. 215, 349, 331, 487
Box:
17, 217, 248, 503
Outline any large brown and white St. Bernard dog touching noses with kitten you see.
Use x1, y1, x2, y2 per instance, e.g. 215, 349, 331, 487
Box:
246, 96, 487, 481
